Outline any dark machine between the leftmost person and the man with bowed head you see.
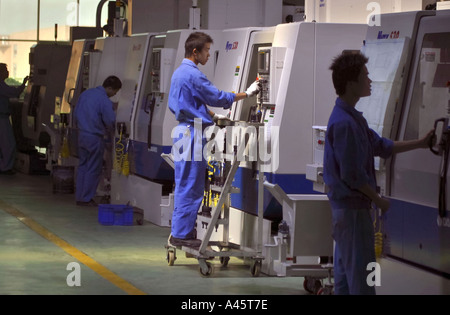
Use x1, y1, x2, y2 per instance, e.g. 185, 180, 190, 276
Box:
12, 42, 71, 173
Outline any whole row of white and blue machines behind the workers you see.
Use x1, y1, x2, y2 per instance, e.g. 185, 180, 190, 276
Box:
20, 11, 450, 292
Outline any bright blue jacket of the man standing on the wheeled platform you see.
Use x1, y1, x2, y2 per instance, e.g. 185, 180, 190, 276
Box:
169, 59, 235, 126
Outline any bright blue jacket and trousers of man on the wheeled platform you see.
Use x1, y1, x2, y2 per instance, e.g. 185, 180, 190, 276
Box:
169, 59, 235, 239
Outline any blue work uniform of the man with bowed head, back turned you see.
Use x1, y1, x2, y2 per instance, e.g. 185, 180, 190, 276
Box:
74, 86, 116, 202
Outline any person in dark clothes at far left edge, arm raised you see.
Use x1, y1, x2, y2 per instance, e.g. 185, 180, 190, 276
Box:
0, 63, 28, 175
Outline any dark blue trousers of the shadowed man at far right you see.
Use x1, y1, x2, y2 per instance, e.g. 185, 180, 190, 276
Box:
332, 209, 376, 295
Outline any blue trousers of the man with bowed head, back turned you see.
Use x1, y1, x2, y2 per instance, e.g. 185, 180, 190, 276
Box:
75, 131, 105, 202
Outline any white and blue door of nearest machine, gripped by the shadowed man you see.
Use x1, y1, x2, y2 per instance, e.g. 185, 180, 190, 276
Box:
386, 15, 450, 276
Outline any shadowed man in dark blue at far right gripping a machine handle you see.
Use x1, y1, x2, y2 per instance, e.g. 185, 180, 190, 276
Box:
324, 54, 434, 295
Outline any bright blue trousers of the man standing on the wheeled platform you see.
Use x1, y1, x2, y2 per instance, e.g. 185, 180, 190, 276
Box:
172, 124, 207, 239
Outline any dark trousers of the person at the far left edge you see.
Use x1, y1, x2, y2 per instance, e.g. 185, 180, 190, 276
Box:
0, 115, 16, 172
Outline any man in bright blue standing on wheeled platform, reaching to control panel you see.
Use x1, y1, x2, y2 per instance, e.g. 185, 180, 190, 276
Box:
169, 32, 260, 246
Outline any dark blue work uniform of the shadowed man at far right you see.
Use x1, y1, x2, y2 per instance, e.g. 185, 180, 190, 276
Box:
324, 98, 394, 294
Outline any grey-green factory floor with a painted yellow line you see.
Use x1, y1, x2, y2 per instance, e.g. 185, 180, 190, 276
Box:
0, 173, 448, 296
